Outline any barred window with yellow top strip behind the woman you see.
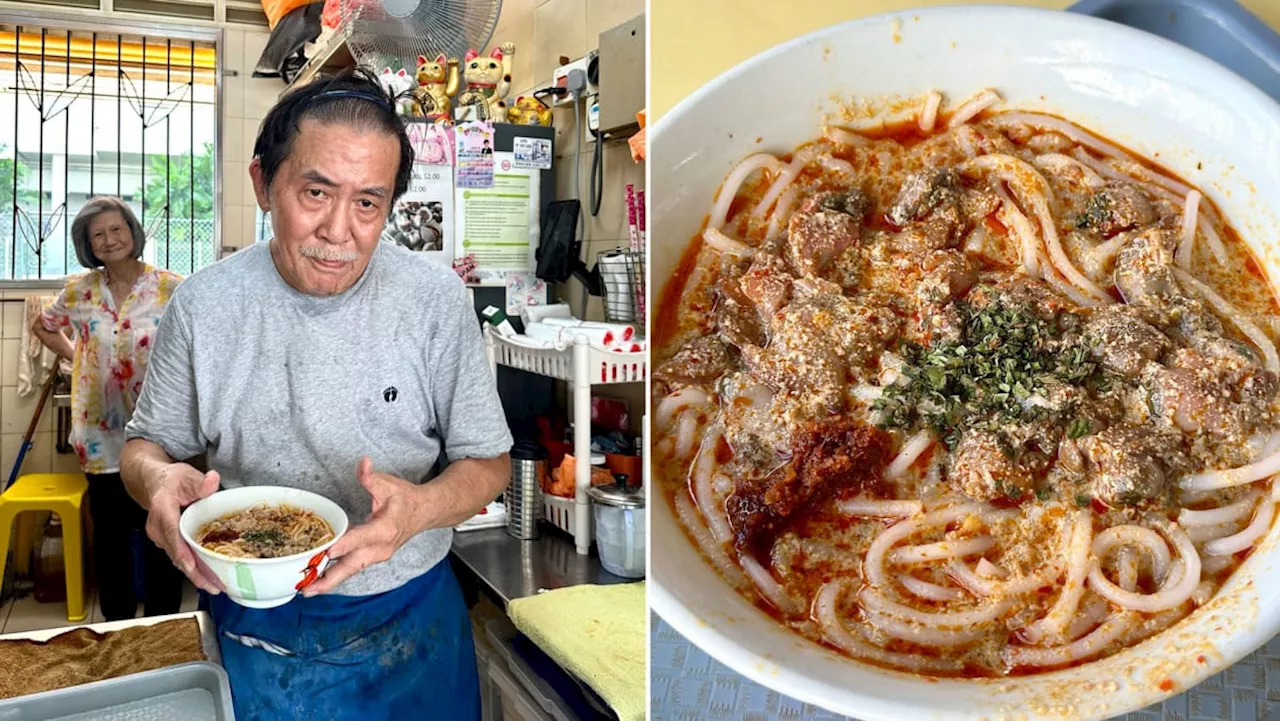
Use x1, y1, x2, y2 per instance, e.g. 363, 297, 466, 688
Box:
0, 17, 219, 280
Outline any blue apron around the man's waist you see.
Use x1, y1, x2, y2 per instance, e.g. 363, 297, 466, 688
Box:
204, 561, 480, 721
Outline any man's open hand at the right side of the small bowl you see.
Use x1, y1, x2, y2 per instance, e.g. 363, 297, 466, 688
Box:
302, 456, 428, 595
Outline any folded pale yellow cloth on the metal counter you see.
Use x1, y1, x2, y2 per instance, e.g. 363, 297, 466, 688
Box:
507, 581, 648, 721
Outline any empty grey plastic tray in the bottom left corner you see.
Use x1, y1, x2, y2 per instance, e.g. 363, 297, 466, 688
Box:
0, 661, 236, 721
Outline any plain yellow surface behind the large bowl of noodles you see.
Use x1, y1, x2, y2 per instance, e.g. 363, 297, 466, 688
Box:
649, 0, 1280, 120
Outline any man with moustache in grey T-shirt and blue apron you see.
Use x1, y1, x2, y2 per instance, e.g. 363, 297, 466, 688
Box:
122, 66, 511, 720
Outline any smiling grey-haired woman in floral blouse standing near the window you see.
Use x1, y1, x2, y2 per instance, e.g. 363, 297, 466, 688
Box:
32, 197, 182, 621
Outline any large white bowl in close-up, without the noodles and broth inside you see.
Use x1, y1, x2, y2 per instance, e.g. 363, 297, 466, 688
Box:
649, 6, 1280, 721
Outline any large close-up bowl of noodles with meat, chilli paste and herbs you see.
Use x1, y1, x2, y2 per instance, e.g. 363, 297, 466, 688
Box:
650, 8, 1280, 720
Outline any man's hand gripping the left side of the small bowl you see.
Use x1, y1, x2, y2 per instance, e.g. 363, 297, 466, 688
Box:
147, 464, 223, 595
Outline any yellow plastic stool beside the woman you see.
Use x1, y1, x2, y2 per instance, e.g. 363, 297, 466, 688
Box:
0, 473, 88, 624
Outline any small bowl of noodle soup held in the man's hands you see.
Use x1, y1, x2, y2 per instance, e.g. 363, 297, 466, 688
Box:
178, 485, 348, 608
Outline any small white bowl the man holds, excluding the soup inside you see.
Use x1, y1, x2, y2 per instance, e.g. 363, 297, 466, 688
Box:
178, 485, 348, 608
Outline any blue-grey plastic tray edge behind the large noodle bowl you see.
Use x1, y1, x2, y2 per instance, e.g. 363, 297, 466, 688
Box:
1068, 0, 1280, 101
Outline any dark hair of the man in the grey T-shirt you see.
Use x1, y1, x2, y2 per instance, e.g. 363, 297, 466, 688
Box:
253, 68, 413, 204
